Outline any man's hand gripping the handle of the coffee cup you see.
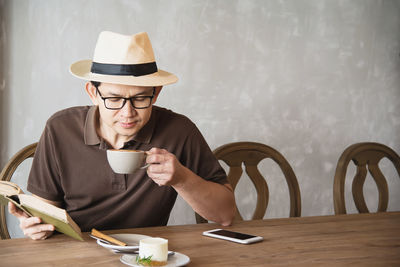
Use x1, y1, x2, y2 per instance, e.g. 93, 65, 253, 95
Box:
146, 148, 186, 186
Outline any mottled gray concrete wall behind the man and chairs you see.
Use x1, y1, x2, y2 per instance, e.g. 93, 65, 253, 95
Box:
0, 0, 400, 239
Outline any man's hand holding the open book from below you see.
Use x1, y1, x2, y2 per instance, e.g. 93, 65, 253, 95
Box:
8, 202, 54, 240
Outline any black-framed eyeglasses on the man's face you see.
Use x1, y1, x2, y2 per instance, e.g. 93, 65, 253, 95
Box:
96, 87, 156, 110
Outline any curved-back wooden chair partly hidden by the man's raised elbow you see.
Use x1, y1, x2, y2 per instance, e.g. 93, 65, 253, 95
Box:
195, 142, 301, 223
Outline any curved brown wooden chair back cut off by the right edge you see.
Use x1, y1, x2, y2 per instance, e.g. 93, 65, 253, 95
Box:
333, 142, 400, 214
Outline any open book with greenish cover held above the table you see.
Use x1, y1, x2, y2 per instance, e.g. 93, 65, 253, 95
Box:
0, 181, 83, 241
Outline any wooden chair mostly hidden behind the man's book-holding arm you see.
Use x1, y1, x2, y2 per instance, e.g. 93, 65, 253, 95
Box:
0, 143, 37, 239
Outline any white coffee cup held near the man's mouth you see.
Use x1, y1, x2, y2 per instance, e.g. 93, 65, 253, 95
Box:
107, 149, 150, 174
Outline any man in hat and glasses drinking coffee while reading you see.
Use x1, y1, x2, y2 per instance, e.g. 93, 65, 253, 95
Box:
9, 32, 235, 239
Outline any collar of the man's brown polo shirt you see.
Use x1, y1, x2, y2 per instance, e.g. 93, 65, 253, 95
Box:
84, 106, 157, 145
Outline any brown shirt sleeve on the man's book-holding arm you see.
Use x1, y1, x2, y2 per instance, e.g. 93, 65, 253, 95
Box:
27, 125, 64, 201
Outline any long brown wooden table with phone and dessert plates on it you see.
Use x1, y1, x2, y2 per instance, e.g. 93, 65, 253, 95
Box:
0, 212, 400, 267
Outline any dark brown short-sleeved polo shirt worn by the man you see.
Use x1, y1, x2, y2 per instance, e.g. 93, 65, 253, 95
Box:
27, 106, 227, 231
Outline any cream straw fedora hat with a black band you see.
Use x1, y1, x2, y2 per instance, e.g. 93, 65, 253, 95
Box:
70, 31, 178, 86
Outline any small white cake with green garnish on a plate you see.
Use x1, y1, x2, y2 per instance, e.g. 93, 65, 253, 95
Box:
136, 237, 168, 266
